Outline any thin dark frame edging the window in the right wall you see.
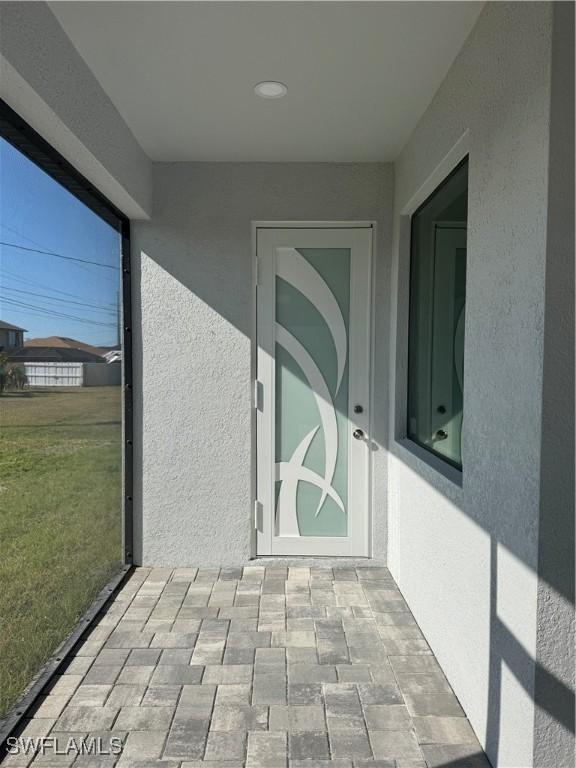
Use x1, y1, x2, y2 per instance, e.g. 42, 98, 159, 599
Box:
404, 153, 470, 473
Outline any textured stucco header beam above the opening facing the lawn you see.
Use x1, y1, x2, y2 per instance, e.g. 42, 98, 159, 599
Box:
0, 2, 152, 218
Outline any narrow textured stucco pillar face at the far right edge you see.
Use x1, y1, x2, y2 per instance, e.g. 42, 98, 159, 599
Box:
534, 3, 576, 768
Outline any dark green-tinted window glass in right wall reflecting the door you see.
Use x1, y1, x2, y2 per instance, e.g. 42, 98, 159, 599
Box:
408, 160, 468, 468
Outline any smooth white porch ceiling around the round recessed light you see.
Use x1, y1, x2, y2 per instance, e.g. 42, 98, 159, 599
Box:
50, 0, 483, 161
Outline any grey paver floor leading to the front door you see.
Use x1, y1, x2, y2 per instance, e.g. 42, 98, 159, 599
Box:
6, 565, 489, 768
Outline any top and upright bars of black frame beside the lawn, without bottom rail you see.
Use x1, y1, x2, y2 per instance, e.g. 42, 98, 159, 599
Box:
0, 99, 134, 569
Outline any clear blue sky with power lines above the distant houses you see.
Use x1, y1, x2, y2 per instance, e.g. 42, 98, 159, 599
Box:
0, 138, 121, 346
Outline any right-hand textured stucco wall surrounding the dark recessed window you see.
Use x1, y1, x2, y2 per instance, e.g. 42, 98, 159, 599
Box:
389, 3, 552, 768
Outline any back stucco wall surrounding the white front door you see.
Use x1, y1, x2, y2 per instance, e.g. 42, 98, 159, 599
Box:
133, 163, 393, 567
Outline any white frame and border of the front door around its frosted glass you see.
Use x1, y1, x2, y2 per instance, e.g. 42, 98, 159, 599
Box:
252, 221, 375, 557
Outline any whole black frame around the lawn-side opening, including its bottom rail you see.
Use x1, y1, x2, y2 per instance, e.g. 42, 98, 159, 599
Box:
0, 99, 134, 762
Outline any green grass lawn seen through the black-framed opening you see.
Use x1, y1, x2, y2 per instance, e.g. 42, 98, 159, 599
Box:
0, 387, 122, 717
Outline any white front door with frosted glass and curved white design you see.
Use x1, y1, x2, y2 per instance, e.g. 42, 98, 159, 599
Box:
256, 226, 372, 556
